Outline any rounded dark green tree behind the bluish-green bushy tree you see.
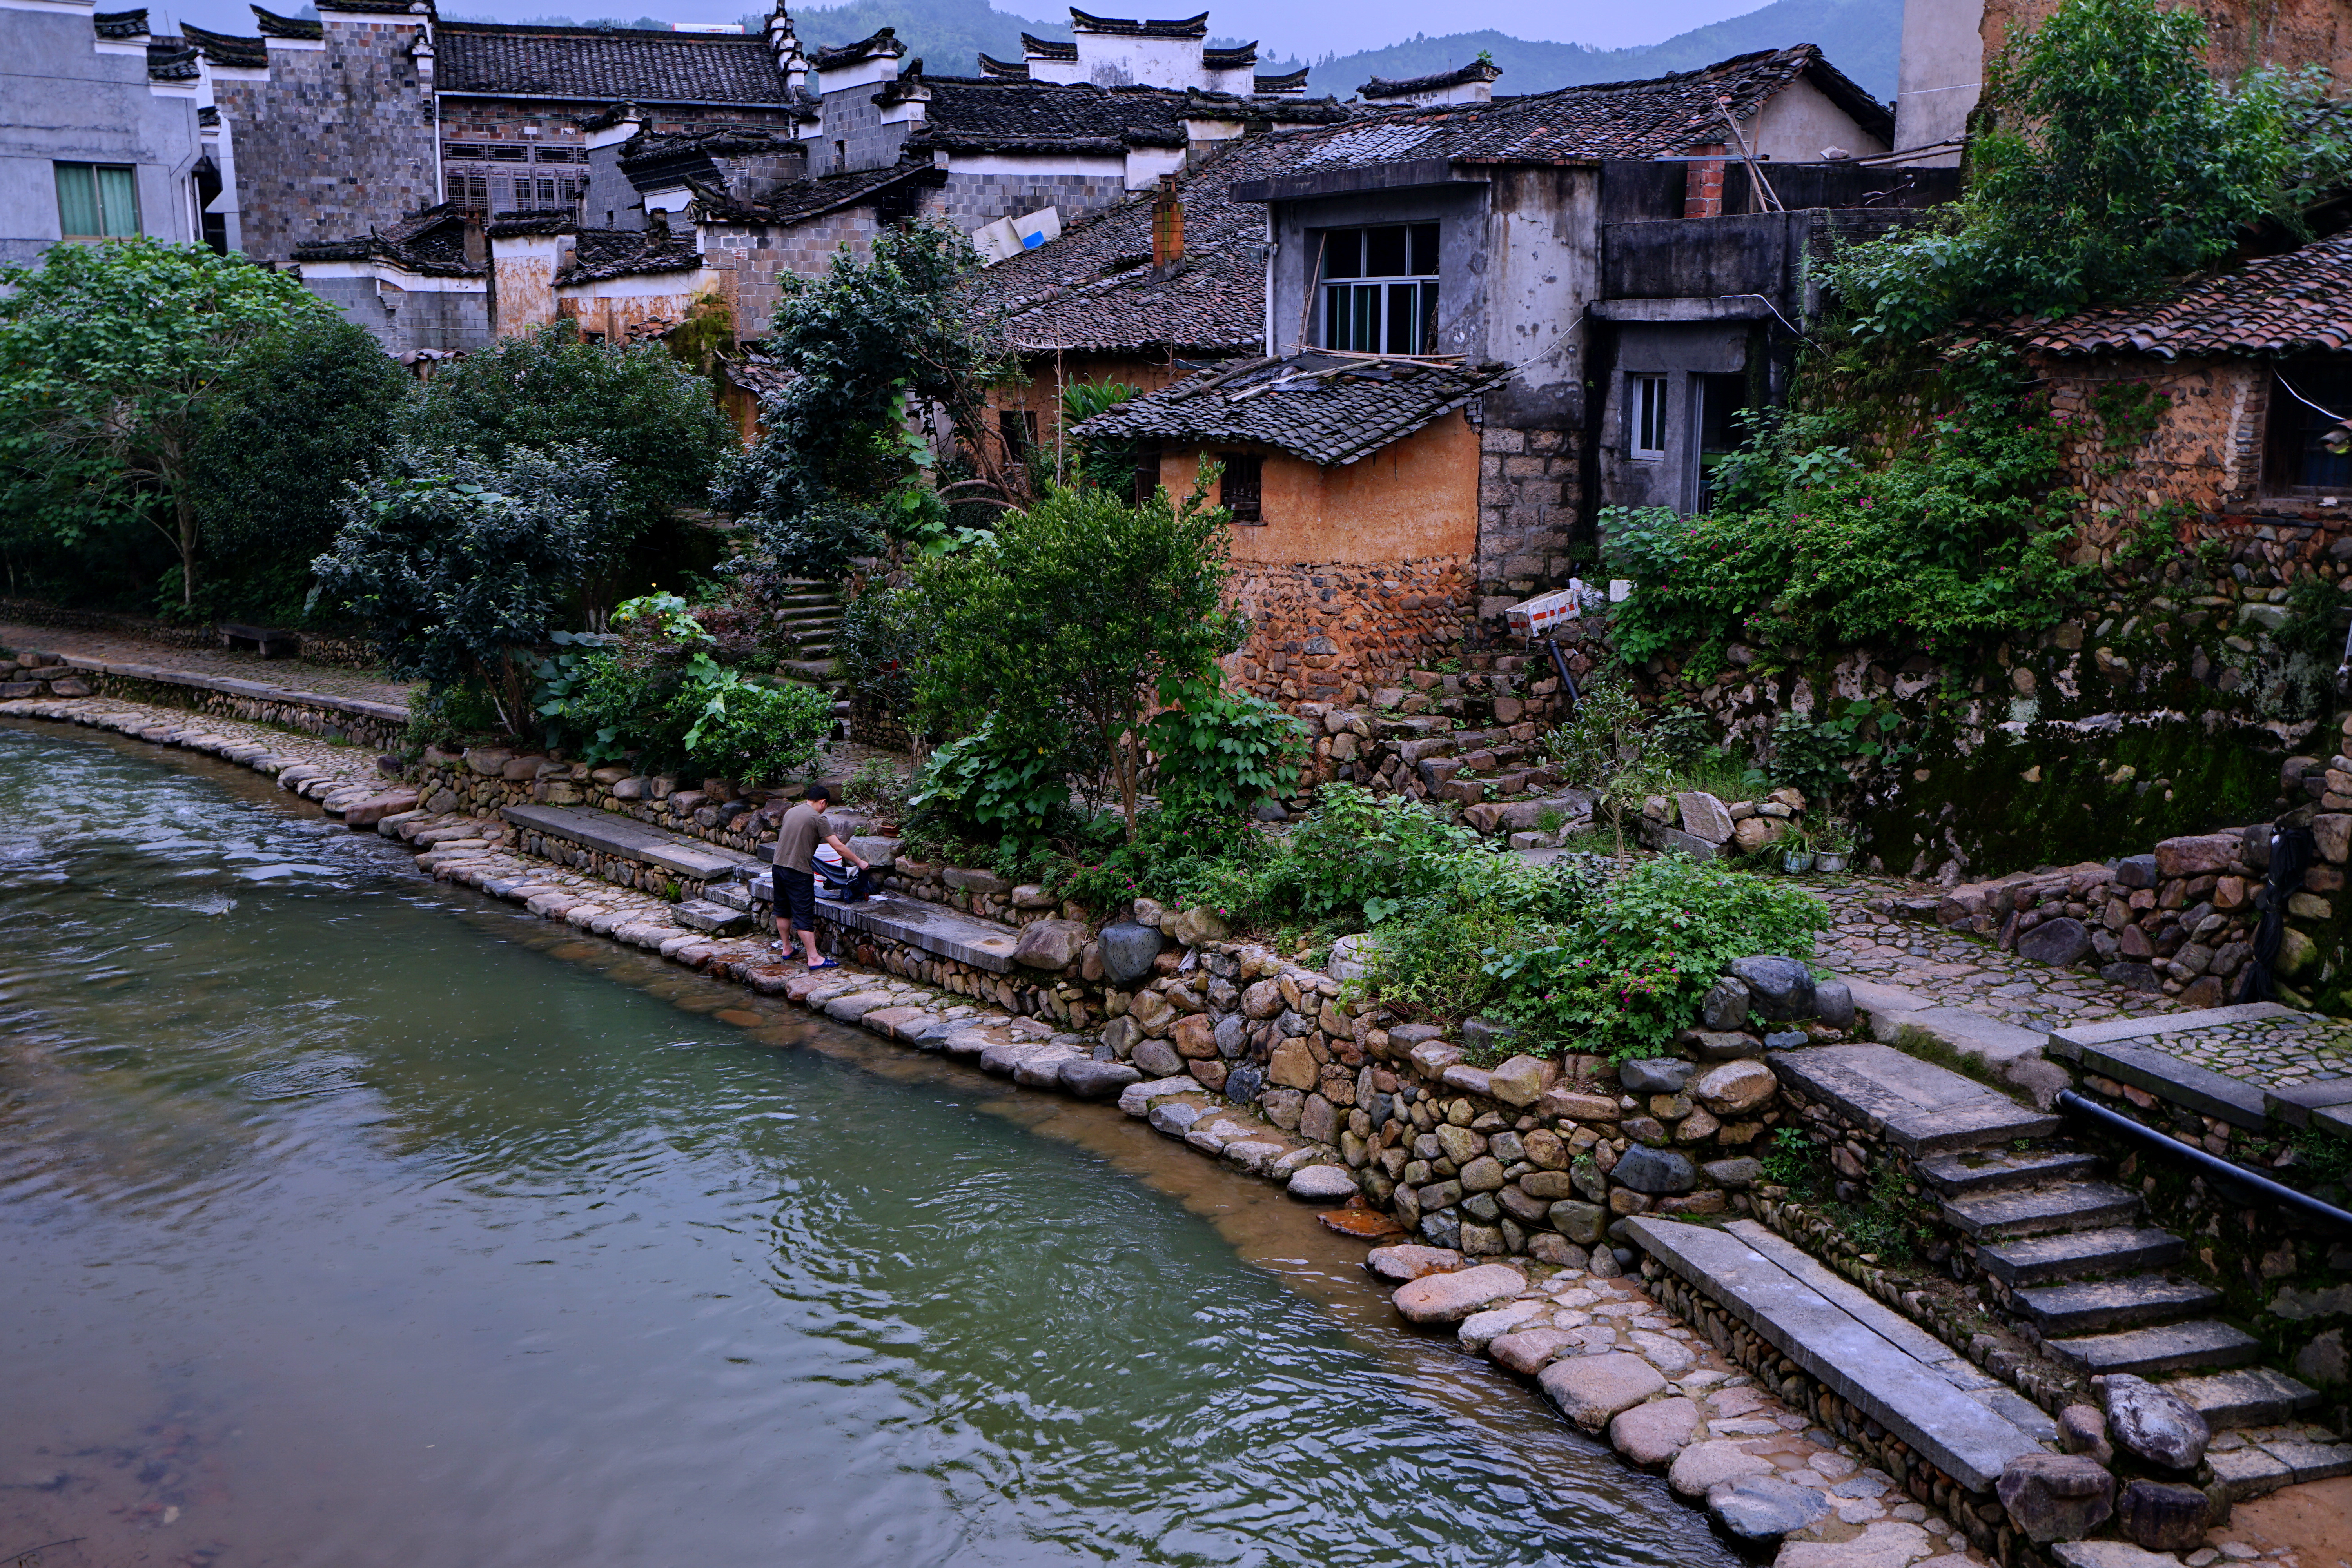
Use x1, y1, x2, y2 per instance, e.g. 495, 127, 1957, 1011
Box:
400, 322, 734, 621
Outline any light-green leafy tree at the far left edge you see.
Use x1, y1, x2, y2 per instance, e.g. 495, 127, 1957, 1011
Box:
0, 238, 332, 606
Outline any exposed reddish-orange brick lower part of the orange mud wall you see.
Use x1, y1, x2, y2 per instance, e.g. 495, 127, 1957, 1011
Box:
1232, 557, 1472, 705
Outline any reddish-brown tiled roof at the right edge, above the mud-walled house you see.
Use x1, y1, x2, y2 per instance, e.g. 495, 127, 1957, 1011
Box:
2016, 235, 2352, 360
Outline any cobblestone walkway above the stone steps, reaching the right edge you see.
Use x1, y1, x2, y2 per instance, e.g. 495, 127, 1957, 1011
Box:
1804, 877, 2352, 1086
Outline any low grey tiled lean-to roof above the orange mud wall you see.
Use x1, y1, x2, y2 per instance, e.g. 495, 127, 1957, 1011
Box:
1077, 348, 1512, 468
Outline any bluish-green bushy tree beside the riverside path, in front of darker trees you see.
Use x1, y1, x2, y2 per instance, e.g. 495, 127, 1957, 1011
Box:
310, 446, 621, 733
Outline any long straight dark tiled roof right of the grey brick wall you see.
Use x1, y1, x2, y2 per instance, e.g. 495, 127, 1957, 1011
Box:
435, 21, 786, 103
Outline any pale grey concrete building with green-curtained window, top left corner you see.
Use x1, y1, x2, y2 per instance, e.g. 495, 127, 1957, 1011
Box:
0, 0, 209, 263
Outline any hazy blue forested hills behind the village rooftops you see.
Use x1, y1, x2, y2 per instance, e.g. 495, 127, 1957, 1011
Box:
781, 0, 1903, 99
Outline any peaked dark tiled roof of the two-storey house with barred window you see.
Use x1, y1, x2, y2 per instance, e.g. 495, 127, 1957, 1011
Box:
1251, 45, 1893, 172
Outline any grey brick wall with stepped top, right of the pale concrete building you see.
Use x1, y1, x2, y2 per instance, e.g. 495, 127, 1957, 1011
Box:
214, 12, 440, 261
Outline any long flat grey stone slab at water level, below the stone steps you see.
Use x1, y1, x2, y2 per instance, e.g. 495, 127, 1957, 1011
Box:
1625, 1222, 2042, 1490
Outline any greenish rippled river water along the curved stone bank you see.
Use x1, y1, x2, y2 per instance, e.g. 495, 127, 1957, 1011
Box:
0, 729, 1726, 1568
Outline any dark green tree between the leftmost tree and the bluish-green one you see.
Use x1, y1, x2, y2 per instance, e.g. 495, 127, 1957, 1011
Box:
188, 315, 416, 618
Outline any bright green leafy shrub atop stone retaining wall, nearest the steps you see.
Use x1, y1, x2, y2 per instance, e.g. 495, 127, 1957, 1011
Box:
1484, 856, 1830, 1056
